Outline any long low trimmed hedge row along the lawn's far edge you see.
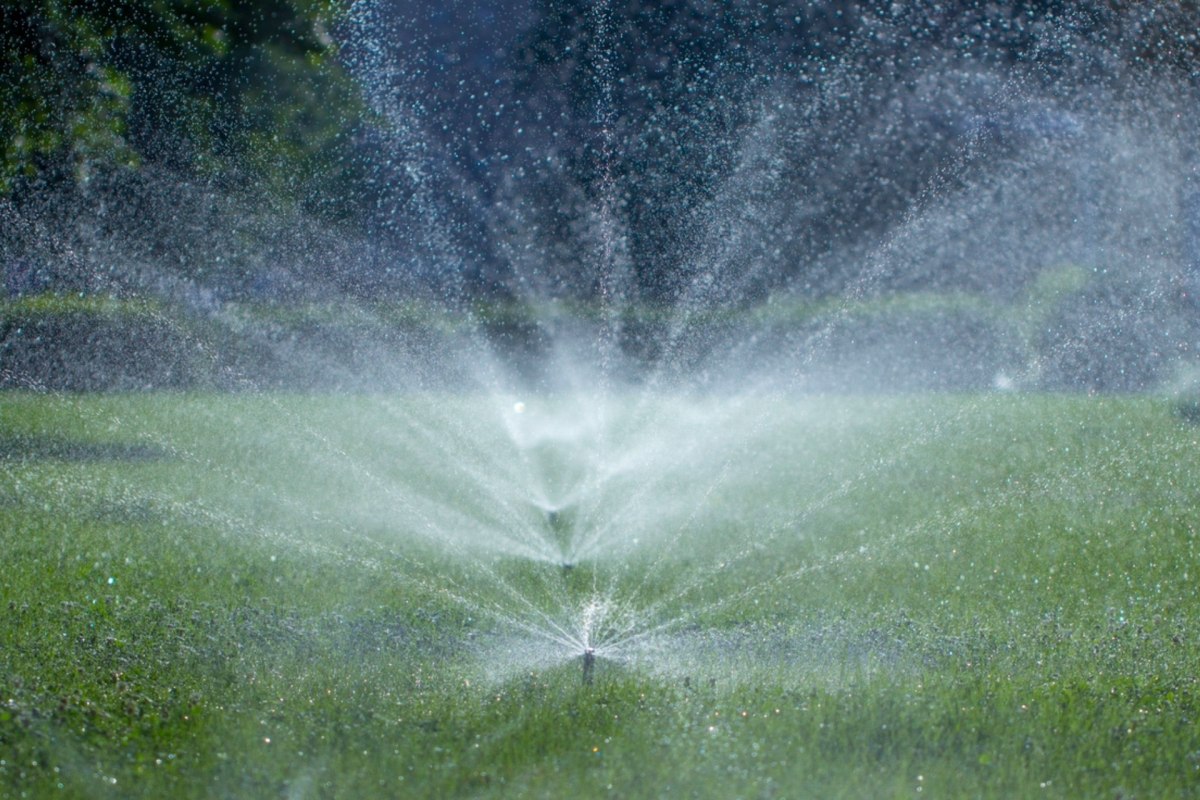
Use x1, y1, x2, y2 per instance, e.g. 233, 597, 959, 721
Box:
0, 301, 1188, 391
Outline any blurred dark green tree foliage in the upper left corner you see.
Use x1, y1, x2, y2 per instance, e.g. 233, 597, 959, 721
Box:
0, 0, 360, 213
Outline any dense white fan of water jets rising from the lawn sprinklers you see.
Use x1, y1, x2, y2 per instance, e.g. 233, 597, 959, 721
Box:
147, 2, 1200, 680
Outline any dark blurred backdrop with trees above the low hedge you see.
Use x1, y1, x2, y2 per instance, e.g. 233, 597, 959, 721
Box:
0, 0, 1200, 387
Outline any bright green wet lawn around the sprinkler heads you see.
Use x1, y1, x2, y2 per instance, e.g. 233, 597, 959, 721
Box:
0, 393, 1200, 799
